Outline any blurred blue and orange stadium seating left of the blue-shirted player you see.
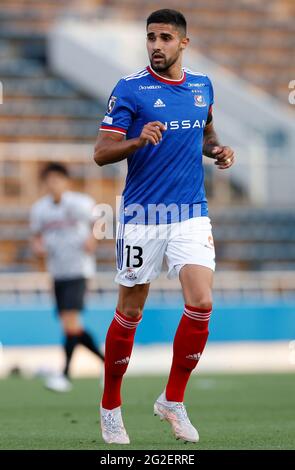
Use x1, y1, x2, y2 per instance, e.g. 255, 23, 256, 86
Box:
0, 0, 117, 272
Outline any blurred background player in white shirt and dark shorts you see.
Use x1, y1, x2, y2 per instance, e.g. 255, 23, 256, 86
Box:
30, 163, 104, 392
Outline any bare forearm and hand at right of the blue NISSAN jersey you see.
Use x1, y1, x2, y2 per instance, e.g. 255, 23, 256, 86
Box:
203, 114, 235, 170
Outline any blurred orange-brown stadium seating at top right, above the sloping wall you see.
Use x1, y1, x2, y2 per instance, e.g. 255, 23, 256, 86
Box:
103, 0, 295, 103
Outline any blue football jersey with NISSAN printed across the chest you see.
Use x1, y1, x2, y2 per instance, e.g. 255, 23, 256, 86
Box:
100, 67, 213, 224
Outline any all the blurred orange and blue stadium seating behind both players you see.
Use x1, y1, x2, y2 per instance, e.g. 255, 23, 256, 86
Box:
0, 0, 295, 272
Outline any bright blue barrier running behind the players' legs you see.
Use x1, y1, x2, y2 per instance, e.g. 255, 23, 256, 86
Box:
0, 297, 295, 346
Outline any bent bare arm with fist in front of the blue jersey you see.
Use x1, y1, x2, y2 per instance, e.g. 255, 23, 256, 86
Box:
93, 121, 166, 166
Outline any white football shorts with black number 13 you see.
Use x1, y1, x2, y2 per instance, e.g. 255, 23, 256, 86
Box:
115, 217, 215, 287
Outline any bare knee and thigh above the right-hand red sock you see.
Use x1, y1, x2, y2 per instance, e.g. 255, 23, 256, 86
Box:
179, 264, 214, 308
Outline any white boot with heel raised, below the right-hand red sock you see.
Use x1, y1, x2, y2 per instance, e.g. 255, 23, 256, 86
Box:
154, 393, 199, 442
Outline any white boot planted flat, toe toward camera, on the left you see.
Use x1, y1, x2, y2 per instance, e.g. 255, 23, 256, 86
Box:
100, 406, 130, 444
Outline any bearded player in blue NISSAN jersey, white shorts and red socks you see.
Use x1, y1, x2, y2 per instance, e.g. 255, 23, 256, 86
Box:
94, 9, 234, 444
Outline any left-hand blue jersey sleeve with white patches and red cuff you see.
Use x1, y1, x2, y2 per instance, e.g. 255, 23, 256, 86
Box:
100, 79, 136, 135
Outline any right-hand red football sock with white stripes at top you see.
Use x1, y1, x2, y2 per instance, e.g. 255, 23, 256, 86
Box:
166, 305, 211, 402
